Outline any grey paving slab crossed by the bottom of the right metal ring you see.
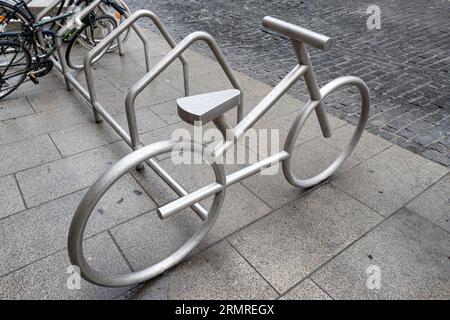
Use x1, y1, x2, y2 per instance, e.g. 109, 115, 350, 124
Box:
242, 140, 357, 209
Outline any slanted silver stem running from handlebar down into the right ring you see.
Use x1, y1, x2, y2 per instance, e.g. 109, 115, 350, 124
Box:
292, 40, 332, 138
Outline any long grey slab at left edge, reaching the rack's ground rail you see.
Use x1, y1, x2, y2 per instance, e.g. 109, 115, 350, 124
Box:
0, 105, 93, 145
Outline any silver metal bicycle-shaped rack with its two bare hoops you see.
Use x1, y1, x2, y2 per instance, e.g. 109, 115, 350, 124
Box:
68, 10, 370, 287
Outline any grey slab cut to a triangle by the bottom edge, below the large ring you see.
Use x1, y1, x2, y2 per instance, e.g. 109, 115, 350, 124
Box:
124, 242, 277, 300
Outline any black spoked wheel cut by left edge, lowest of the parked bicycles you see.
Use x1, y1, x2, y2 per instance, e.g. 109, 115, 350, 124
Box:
0, 40, 31, 99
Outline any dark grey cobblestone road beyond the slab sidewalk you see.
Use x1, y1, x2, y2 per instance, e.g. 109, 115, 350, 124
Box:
129, 0, 450, 166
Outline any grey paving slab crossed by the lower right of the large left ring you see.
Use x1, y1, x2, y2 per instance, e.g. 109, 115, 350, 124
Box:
112, 183, 270, 269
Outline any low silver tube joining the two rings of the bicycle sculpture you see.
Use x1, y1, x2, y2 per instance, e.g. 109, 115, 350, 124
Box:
156, 151, 289, 219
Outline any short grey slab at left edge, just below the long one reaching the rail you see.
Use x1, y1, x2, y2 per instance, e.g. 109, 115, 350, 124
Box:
0, 134, 61, 176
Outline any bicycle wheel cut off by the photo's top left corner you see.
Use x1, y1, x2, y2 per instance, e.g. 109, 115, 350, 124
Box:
0, 1, 33, 33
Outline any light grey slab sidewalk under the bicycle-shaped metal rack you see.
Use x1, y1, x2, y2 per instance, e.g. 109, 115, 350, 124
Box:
0, 28, 450, 299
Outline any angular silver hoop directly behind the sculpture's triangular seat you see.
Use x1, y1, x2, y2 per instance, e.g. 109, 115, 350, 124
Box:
125, 31, 244, 147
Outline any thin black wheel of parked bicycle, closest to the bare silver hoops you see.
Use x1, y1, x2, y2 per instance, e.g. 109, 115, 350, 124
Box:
66, 16, 116, 70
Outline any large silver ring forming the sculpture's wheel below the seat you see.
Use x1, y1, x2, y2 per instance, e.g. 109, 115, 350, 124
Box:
68, 141, 225, 287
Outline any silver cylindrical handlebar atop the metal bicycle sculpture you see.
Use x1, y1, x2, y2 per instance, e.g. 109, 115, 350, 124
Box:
263, 16, 333, 51
